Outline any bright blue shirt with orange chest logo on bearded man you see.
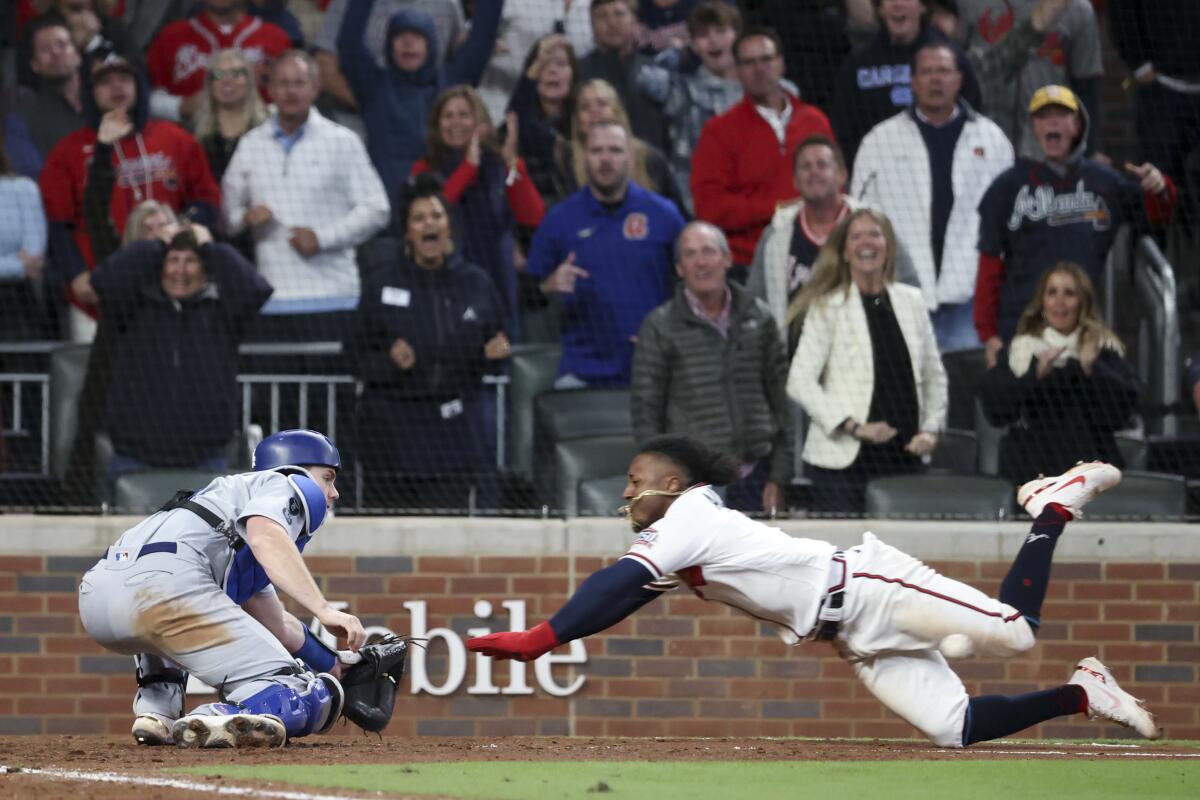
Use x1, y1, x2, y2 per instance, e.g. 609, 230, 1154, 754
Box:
528, 182, 684, 386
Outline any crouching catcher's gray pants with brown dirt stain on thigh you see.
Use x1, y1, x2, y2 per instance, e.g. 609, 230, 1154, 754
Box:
79, 545, 311, 720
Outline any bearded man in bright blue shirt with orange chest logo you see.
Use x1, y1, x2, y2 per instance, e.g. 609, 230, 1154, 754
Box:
528, 122, 684, 389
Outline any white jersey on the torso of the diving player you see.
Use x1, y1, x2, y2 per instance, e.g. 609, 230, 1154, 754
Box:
622, 486, 838, 644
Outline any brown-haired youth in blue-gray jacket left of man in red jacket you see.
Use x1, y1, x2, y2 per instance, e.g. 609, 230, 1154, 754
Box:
637, 0, 742, 215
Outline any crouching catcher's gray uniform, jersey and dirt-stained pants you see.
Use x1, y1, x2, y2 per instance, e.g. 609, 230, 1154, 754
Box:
79, 469, 328, 735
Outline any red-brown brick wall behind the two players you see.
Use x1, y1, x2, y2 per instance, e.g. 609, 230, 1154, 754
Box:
0, 555, 1200, 739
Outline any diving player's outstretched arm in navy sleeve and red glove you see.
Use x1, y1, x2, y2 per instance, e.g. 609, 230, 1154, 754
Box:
467, 559, 662, 661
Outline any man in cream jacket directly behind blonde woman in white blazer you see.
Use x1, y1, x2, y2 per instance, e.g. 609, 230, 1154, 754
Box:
746, 133, 919, 355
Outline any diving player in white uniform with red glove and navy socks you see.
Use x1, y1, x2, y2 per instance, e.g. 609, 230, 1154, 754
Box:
467, 437, 1159, 747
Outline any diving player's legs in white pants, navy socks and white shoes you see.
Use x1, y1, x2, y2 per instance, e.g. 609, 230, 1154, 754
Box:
842, 462, 1158, 747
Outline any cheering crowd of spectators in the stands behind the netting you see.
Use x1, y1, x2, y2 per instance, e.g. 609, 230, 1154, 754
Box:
0, 0, 1200, 513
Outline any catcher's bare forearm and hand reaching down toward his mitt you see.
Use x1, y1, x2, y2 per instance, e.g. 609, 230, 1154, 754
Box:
246, 517, 366, 650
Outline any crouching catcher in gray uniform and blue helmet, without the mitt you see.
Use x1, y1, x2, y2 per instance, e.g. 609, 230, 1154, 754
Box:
79, 431, 362, 747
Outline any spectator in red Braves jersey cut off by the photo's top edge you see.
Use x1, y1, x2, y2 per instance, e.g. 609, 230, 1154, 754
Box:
146, 0, 292, 120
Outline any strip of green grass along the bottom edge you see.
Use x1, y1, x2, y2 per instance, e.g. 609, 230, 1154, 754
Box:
175, 758, 1200, 800
